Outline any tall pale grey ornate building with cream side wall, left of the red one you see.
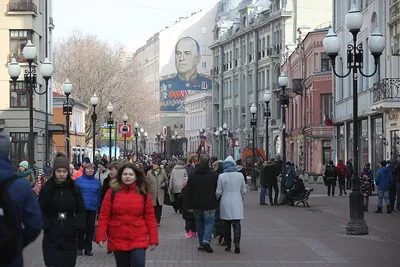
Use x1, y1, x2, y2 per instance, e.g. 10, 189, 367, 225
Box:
211, 0, 332, 160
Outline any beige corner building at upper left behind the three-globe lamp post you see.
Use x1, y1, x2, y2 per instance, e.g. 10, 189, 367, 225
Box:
0, 0, 60, 167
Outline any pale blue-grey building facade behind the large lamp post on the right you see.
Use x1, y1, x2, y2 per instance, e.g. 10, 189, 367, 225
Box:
333, 0, 400, 174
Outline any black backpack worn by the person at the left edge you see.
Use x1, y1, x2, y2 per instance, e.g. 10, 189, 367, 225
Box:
0, 177, 21, 264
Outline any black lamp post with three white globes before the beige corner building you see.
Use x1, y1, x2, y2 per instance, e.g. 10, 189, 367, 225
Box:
8, 40, 53, 169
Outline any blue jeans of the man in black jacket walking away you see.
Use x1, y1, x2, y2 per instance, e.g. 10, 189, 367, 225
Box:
194, 210, 215, 245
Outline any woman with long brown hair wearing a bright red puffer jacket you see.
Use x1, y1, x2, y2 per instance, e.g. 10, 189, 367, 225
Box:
96, 163, 158, 267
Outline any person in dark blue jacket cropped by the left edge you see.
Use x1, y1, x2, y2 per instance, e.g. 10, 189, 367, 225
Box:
0, 134, 42, 267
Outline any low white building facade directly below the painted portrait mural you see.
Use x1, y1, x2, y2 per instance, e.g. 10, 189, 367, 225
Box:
184, 91, 213, 154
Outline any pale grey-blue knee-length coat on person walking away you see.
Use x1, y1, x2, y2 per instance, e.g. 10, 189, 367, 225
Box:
216, 172, 246, 220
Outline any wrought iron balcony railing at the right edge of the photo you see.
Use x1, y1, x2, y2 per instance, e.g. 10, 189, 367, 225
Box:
372, 78, 400, 103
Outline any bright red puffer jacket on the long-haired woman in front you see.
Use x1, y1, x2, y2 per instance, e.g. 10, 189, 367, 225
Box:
96, 179, 158, 251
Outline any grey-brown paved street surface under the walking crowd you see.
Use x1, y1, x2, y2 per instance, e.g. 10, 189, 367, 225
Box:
24, 184, 400, 267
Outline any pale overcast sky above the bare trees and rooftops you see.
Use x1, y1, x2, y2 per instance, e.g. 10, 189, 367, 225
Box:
53, 0, 218, 52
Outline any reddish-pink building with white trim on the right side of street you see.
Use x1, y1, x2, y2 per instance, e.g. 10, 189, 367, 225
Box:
283, 26, 334, 174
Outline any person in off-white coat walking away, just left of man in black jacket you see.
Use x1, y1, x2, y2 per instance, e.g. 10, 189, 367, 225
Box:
169, 160, 188, 213
